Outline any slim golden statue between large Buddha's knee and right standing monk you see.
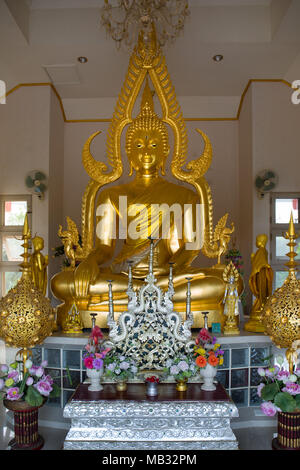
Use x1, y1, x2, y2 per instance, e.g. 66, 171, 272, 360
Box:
223, 261, 240, 335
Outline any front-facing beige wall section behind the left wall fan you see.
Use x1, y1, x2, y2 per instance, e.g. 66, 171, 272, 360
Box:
0, 87, 50, 246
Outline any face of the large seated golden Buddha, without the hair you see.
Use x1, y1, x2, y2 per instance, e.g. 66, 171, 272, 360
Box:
128, 130, 169, 175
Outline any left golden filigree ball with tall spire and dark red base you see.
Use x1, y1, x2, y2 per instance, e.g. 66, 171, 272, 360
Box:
0, 214, 54, 450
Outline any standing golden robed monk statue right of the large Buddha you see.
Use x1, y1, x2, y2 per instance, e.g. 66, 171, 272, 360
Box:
245, 234, 273, 333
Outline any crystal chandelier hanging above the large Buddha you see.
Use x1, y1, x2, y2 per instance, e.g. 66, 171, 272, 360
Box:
101, 0, 190, 47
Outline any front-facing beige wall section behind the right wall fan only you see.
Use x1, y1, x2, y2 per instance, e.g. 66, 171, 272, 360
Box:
252, 83, 300, 241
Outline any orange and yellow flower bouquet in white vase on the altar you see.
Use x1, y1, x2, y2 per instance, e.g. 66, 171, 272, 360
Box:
194, 328, 224, 369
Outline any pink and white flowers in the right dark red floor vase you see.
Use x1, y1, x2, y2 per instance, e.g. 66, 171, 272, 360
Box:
257, 356, 300, 416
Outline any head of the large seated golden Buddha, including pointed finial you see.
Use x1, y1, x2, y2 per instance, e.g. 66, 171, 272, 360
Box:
126, 82, 170, 175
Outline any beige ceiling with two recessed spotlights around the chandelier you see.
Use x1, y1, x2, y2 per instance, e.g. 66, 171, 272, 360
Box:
0, 0, 300, 99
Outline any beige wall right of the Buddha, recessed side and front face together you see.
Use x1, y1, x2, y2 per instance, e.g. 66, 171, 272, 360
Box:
239, 82, 300, 308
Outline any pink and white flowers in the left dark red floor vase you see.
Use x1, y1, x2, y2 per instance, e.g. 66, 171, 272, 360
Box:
0, 359, 60, 406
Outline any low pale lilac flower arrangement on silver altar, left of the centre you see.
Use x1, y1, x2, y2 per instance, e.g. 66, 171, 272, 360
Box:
104, 351, 138, 382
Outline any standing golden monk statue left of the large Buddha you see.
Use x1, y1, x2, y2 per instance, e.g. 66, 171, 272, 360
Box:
31, 236, 49, 295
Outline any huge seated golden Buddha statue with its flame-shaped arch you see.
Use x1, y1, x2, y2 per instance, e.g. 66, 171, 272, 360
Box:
51, 25, 239, 327
